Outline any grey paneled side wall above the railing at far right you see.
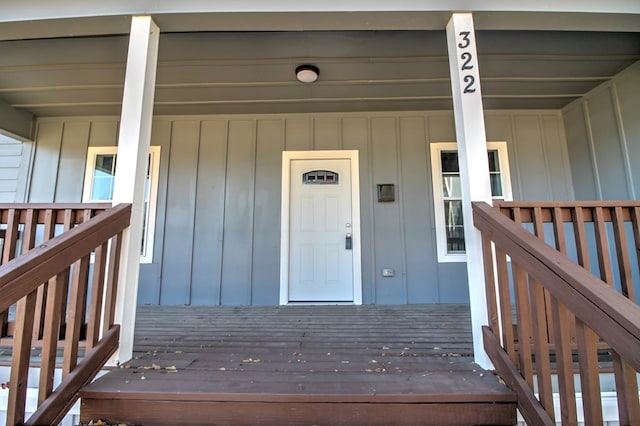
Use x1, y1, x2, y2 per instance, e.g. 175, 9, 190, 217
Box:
562, 62, 640, 200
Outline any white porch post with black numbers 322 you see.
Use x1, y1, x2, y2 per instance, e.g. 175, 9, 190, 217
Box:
447, 13, 491, 368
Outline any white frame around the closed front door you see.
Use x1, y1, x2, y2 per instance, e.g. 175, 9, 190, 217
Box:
280, 150, 362, 305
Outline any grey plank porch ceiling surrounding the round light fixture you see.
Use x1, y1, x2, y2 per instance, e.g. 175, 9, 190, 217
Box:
0, 30, 640, 117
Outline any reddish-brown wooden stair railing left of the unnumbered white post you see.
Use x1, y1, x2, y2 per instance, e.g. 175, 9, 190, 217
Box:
0, 204, 131, 425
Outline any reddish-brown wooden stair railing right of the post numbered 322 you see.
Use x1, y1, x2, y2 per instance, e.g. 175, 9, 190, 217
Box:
473, 201, 640, 425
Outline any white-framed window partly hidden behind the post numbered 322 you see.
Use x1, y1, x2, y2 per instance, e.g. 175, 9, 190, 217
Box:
431, 142, 511, 262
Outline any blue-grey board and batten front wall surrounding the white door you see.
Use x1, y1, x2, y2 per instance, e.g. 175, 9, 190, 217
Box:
21, 111, 573, 305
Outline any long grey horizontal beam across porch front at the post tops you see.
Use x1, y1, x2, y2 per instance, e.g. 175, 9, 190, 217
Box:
0, 11, 640, 41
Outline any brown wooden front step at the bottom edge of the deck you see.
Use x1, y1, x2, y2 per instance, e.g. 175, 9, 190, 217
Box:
81, 366, 516, 425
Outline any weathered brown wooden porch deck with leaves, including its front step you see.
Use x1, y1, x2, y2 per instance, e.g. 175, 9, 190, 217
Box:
81, 305, 516, 425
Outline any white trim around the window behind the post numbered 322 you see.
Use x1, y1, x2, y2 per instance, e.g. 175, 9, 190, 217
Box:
430, 142, 512, 263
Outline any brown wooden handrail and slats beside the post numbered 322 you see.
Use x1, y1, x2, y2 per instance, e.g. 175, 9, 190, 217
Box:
473, 202, 640, 424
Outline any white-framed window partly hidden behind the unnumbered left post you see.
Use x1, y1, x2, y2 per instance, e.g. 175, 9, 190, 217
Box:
82, 146, 160, 263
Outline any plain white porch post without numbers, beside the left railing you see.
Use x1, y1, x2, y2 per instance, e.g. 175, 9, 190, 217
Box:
113, 16, 160, 361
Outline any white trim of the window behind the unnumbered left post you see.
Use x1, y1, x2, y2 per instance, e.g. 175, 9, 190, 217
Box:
82, 146, 160, 263
